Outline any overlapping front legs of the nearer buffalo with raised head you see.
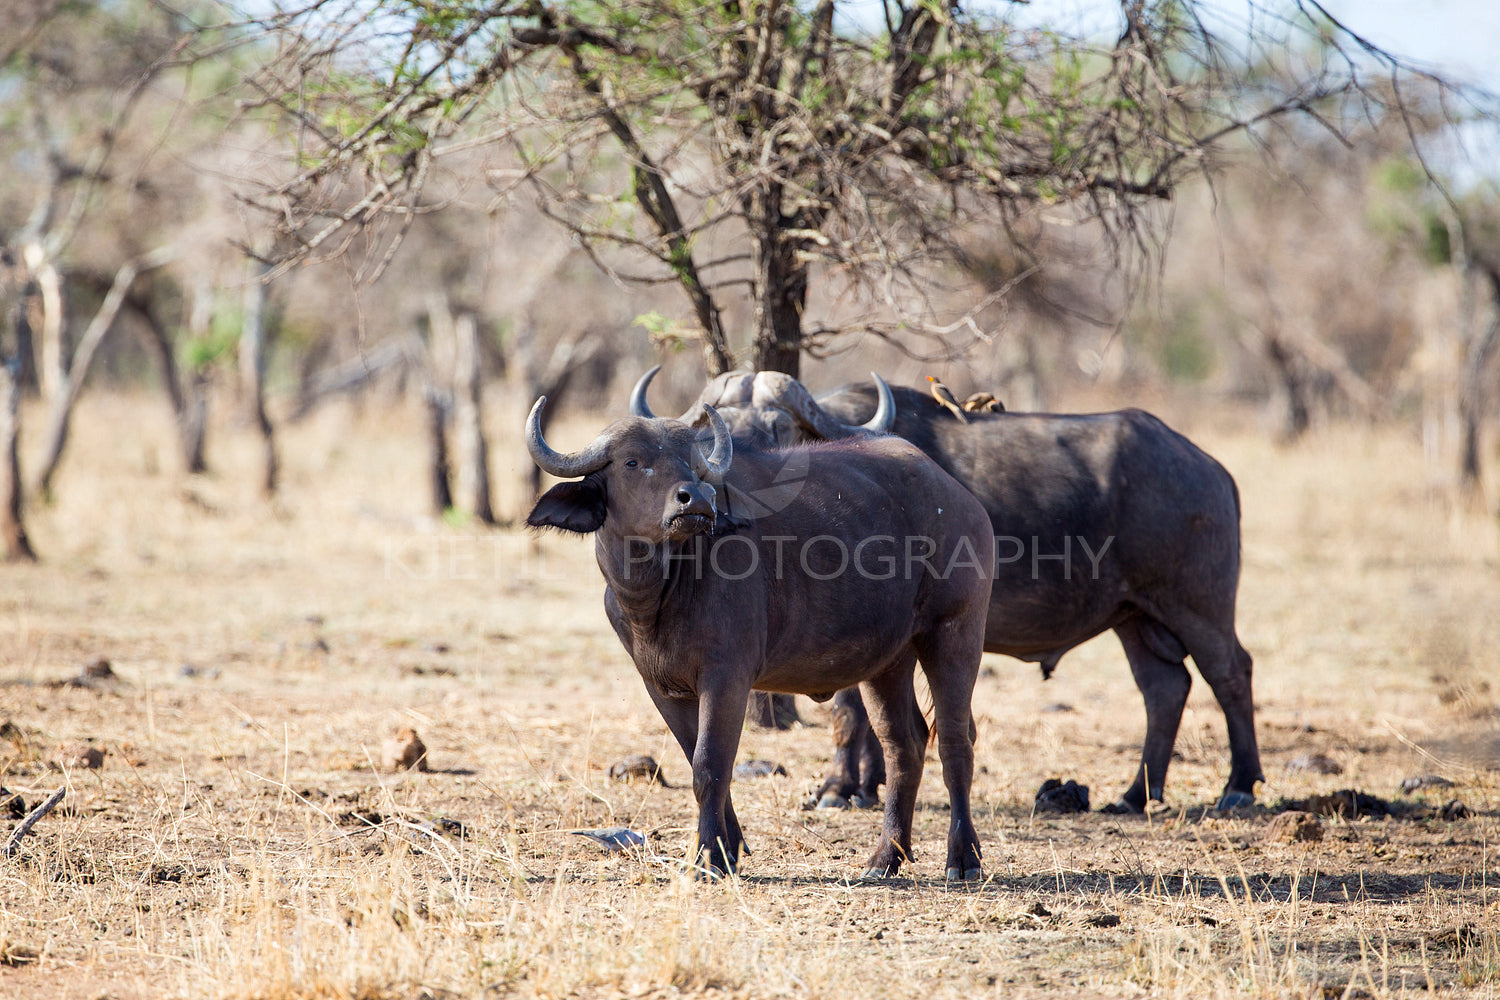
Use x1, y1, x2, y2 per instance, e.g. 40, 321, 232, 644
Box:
647, 684, 750, 876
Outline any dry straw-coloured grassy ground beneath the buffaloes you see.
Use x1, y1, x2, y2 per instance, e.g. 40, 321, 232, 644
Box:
0, 394, 1500, 1000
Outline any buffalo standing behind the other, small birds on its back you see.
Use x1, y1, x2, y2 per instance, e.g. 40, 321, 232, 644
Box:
632, 369, 1265, 813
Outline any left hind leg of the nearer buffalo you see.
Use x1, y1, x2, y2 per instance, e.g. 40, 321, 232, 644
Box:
863, 648, 927, 879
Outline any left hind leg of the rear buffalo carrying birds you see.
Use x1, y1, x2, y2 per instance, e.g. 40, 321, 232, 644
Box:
1104, 615, 1193, 813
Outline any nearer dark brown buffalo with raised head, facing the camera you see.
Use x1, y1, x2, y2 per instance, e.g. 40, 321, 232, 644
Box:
527, 397, 993, 879
